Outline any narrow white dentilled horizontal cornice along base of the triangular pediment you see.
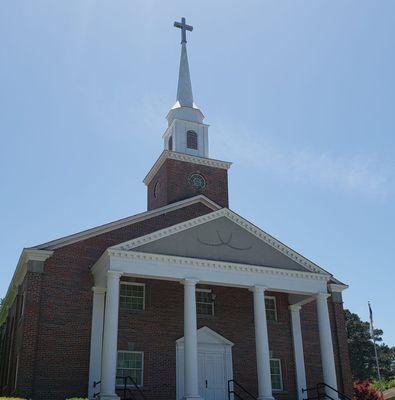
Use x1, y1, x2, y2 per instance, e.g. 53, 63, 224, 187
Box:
107, 248, 330, 281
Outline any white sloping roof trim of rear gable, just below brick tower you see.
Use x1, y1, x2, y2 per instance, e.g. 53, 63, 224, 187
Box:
32, 195, 221, 250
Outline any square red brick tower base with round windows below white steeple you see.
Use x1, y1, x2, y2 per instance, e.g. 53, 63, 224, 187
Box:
147, 159, 229, 210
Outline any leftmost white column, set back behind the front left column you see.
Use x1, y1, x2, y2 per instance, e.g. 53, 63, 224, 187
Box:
88, 286, 106, 399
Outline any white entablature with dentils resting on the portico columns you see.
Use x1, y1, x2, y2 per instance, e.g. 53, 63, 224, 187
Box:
92, 250, 330, 295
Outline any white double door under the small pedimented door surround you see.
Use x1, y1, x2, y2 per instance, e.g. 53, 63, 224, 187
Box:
198, 350, 228, 400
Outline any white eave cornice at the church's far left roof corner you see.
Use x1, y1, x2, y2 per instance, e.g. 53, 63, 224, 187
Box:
0, 249, 53, 325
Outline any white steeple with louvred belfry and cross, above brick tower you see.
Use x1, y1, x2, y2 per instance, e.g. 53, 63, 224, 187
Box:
163, 18, 208, 157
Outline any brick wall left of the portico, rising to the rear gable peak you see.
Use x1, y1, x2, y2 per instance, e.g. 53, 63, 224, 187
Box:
0, 203, 212, 400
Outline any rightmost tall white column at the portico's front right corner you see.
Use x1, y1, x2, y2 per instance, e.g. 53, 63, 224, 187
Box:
316, 293, 337, 398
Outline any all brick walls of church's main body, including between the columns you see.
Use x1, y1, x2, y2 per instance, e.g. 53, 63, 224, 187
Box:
0, 203, 351, 400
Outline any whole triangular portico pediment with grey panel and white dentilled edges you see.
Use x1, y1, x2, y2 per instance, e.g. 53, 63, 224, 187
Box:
113, 209, 328, 274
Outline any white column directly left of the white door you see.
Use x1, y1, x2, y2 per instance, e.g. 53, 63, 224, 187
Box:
182, 279, 201, 400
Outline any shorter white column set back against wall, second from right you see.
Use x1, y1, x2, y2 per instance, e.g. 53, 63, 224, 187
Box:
289, 304, 307, 400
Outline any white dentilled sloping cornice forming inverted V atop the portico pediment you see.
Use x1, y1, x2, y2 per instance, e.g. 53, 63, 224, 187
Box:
110, 208, 331, 276
